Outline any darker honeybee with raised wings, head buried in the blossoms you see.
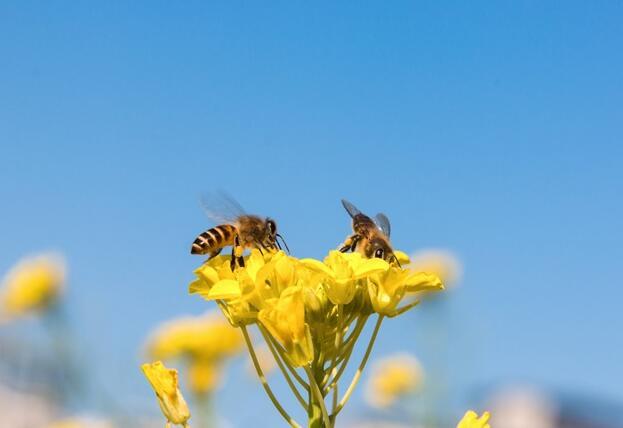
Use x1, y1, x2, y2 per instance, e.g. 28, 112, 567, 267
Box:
340, 199, 400, 265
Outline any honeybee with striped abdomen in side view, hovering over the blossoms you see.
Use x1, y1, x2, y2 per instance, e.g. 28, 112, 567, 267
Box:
190, 195, 290, 270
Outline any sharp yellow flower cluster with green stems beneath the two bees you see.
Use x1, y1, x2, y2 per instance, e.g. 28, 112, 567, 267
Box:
190, 250, 443, 427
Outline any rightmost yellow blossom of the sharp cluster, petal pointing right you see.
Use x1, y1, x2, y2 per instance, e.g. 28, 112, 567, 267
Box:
368, 265, 443, 316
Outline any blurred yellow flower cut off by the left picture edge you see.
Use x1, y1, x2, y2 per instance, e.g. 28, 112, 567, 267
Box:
0, 255, 65, 318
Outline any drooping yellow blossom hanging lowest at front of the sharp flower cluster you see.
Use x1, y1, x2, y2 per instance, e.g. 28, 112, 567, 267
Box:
258, 287, 314, 367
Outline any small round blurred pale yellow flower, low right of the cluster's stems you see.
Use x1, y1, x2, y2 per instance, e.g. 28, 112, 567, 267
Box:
366, 354, 423, 408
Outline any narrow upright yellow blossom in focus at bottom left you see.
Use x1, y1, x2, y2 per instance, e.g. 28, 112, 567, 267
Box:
141, 361, 190, 427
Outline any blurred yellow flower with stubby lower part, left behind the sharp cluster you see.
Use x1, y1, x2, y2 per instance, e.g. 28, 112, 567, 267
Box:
146, 312, 244, 394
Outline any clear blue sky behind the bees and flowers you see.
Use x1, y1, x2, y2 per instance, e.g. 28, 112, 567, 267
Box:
0, 1, 623, 426
